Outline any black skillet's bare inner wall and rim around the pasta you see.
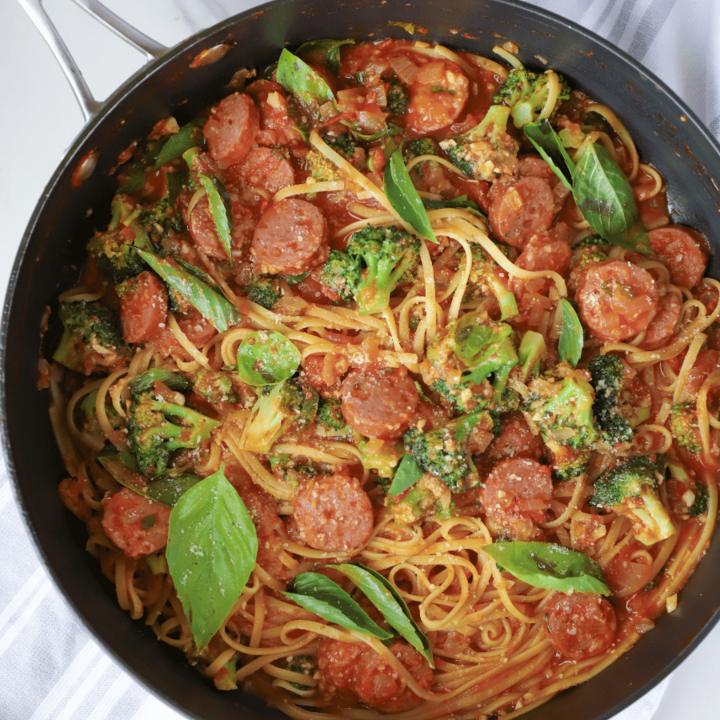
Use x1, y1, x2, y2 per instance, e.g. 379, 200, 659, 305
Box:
0, 0, 720, 720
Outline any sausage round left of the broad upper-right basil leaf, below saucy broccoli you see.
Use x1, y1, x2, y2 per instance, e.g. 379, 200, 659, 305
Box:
489, 175, 555, 248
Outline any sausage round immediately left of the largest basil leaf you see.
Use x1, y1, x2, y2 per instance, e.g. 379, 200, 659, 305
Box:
102, 488, 170, 558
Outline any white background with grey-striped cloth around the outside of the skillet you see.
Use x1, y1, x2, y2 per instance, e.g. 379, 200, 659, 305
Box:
0, 0, 720, 720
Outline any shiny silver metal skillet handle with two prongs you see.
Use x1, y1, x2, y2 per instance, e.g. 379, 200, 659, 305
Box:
18, 0, 168, 122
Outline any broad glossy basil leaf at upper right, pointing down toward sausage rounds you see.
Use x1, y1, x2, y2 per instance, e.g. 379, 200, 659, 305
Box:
573, 144, 652, 253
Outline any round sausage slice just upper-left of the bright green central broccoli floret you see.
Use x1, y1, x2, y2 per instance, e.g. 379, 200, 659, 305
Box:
251, 198, 329, 275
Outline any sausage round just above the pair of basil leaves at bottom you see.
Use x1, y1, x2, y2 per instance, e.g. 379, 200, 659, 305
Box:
293, 473, 374, 550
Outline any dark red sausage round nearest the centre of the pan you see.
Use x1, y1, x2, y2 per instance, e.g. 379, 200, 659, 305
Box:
340, 365, 420, 440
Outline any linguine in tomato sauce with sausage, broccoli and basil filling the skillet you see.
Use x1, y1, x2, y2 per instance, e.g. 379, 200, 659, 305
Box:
47, 35, 720, 720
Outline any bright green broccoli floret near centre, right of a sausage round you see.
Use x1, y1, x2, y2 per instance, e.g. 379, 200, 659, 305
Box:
320, 225, 420, 315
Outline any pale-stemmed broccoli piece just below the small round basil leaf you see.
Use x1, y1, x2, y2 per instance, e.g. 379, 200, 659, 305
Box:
242, 378, 318, 453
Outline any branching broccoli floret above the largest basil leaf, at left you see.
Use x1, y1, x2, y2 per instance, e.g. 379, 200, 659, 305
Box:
127, 370, 220, 480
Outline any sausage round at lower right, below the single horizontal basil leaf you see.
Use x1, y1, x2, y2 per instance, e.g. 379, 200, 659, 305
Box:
545, 593, 617, 660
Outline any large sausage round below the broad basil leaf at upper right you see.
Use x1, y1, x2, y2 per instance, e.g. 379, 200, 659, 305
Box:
575, 260, 660, 342
